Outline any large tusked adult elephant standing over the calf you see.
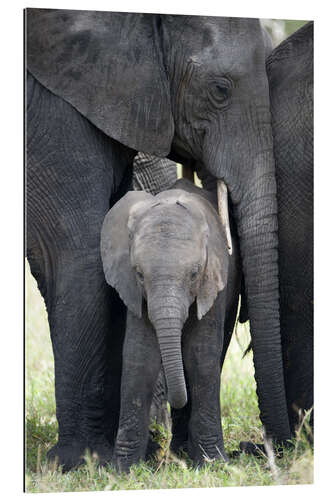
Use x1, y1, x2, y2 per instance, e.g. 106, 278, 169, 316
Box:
27, 9, 290, 469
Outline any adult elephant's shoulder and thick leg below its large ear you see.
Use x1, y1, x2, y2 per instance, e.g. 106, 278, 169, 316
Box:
27, 75, 132, 470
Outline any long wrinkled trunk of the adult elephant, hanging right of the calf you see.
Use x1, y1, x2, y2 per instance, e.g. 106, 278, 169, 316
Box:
235, 152, 290, 441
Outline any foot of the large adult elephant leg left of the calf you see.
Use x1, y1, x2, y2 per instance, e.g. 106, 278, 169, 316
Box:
47, 442, 88, 472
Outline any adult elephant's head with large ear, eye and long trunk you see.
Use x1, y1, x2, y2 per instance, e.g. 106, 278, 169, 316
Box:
27, 9, 290, 439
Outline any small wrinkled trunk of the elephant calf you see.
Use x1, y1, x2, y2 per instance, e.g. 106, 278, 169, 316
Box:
149, 297, 187, 408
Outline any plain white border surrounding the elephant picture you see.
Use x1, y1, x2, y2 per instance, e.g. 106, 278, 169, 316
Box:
0, 0, 333, 500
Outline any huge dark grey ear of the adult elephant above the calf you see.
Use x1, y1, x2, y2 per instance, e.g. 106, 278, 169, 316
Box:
26, 9, 174, 156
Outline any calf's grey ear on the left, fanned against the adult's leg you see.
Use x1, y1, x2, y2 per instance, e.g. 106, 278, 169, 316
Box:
101, 191, 154, 318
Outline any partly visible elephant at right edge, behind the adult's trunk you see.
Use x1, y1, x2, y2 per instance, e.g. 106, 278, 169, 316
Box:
267, 23, 313, 432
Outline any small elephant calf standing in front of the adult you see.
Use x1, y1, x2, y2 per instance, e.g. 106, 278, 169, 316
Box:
101, 180, 240, 471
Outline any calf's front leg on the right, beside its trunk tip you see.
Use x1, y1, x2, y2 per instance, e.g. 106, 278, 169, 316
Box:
183, 292, 228, 465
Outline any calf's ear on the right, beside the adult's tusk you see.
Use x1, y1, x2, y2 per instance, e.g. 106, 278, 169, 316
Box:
197, 199, 229, 320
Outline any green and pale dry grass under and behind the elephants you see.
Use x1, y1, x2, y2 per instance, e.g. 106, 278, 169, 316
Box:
25, 266, 313, 493
